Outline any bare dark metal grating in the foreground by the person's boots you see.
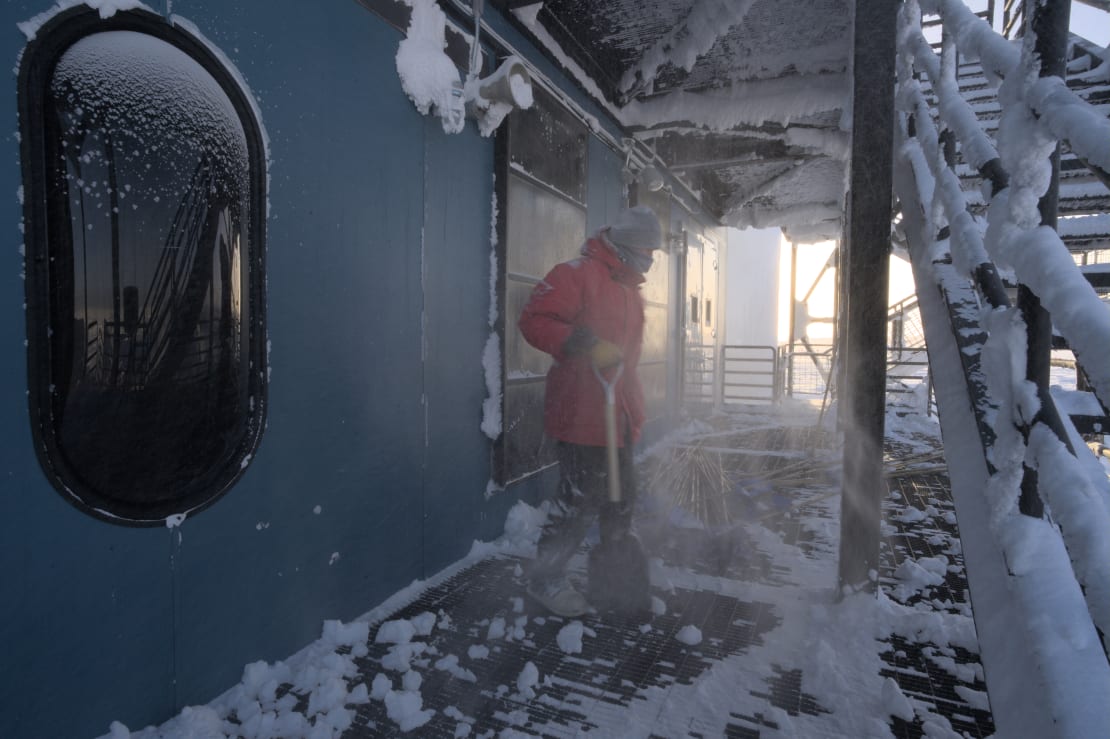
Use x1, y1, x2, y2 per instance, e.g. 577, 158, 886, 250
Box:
344, 557, 778, 737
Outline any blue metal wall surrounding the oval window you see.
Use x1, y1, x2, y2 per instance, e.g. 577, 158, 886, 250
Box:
0, 0, 719, 739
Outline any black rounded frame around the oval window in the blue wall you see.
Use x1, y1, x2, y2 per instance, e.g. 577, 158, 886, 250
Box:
17, 6, 269, 526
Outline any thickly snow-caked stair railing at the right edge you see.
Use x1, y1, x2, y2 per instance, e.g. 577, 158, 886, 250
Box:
896, 0, 1110, 736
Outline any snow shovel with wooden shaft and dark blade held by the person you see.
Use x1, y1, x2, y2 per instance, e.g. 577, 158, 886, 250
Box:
587, 363, 652, 616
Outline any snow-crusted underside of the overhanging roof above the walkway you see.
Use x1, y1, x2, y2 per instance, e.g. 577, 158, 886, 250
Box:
492, 0, 852, 241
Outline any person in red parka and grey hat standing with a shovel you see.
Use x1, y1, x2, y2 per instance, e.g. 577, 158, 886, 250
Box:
519, 205, 663, 617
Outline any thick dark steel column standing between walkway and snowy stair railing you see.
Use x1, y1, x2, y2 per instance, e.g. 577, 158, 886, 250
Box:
839, 0, 900, 588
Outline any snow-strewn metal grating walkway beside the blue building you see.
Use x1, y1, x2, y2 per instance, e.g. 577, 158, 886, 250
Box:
140, 406, 993, 739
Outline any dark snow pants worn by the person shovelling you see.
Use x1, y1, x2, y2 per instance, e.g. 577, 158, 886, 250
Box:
528, 434, 636, 584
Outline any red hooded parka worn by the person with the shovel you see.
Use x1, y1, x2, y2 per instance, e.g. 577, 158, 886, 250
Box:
519, 236, 644, 446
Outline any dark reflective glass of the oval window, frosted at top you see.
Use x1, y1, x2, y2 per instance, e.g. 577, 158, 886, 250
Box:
21, 18, 263, 522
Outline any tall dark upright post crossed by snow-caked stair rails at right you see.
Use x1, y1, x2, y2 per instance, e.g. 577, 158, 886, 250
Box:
1018, 0, 1070, 518
